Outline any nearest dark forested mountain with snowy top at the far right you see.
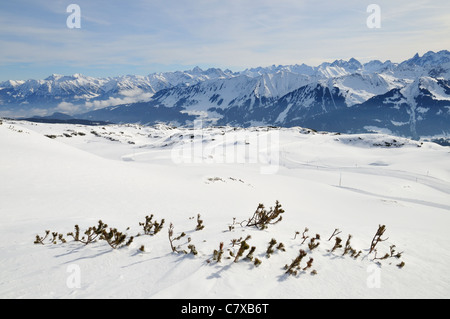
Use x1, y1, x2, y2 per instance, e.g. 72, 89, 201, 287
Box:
298, 77, 450, 138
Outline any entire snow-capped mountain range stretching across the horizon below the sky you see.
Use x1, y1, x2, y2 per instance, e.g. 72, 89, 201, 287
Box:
0, 50, 450, 138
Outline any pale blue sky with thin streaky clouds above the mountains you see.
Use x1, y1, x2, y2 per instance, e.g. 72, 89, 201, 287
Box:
0, 0, 450, 81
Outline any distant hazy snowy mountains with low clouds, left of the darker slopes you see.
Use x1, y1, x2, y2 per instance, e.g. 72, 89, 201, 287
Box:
0, 68, 237, 117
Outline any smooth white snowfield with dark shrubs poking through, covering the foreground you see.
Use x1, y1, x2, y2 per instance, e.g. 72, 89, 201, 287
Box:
0, 120, 450, 299
